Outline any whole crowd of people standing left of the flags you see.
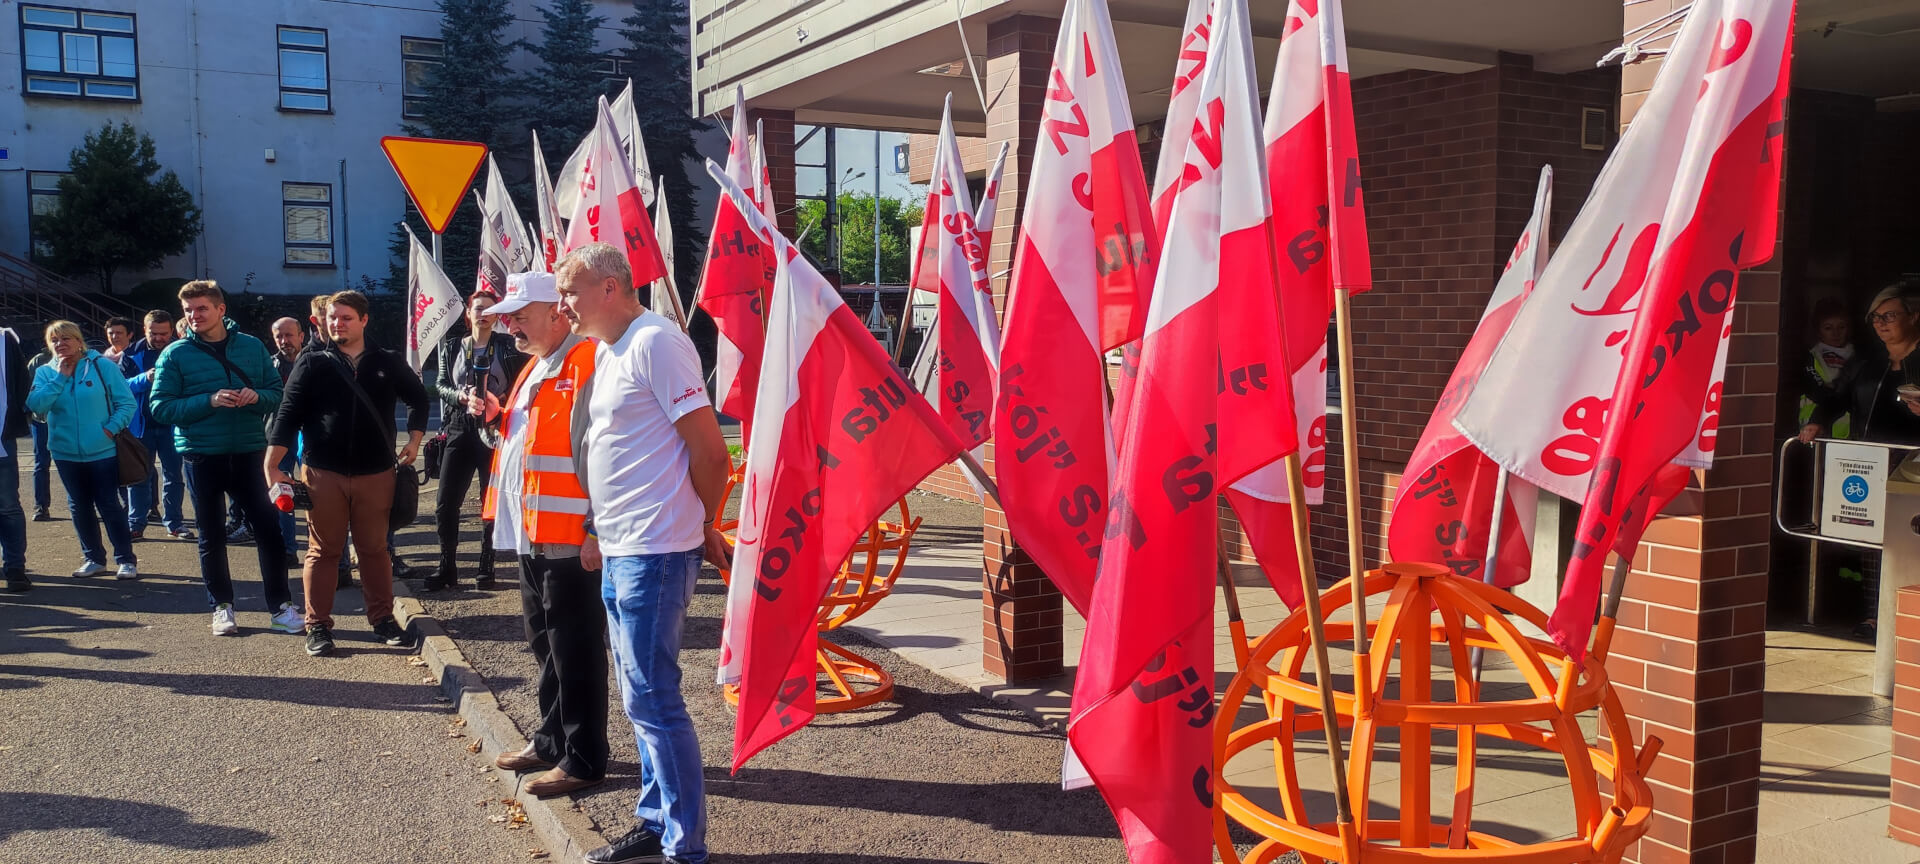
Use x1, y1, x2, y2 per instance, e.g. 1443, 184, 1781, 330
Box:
0, 244, 730, 864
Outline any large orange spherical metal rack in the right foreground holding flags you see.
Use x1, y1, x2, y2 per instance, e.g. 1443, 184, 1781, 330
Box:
1213, 563, 1661, 864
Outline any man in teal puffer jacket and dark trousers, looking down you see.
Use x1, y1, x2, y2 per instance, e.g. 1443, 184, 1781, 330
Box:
150, 280, 305, 636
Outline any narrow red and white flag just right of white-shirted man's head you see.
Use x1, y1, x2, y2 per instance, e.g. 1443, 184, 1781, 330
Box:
695, 88, 774, 442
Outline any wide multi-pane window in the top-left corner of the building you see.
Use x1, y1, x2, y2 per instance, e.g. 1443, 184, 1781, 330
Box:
19, 6, 140, 102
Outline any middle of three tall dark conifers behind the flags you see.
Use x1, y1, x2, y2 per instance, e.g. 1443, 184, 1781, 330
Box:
522, 0, 618, 173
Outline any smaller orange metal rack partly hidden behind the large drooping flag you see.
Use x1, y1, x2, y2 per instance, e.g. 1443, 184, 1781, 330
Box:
716, 472, 920, 714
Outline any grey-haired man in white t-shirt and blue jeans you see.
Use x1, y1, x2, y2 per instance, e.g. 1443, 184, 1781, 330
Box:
555, 244, 732, 864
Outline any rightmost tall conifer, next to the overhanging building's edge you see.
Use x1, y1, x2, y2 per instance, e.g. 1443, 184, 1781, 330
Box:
620, 0, 707, 301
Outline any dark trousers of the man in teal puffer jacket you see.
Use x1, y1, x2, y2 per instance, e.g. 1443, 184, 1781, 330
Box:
184, 449, 294, 612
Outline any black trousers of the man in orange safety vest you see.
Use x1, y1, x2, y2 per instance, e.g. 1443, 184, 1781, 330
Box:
520, 555, 607, 780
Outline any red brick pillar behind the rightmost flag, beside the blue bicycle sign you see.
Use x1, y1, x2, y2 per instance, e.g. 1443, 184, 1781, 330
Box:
1607, 0, 1791, 864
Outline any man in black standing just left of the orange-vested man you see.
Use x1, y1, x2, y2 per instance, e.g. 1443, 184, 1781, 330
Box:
424, 288, 526, 591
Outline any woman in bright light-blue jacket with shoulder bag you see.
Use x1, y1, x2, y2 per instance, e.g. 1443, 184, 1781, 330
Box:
27, 321, 140, 580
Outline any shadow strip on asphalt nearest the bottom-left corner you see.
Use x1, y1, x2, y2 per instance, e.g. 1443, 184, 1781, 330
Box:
0, 793, 271, 849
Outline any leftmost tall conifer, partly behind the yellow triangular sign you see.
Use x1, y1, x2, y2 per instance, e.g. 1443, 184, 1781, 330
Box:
386, 0, 528, 292
